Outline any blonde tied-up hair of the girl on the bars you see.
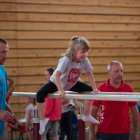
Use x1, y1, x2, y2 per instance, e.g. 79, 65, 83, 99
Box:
63, 36, 89, 58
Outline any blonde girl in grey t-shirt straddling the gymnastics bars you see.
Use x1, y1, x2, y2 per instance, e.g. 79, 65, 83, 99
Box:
37, 37, 99, 134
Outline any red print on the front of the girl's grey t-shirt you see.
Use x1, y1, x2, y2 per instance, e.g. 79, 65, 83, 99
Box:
67, 68, 81, 83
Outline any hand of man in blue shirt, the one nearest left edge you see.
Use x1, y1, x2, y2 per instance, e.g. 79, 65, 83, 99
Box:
0, 110, 14, 122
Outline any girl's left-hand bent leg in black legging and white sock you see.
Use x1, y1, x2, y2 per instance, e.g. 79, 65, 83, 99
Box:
37, 82, 57, 134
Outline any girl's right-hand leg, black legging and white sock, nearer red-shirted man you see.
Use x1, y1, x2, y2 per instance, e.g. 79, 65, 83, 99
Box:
70, 81, 99, 124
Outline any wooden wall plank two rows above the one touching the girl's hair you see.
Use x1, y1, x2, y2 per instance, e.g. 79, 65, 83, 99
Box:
16, 13, 140, 24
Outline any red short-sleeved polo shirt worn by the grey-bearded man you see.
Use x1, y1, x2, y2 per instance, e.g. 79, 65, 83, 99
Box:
92, 79, 137, 134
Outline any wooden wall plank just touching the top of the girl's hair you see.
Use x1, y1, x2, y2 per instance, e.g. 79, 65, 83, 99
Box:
17, 31, 140, 40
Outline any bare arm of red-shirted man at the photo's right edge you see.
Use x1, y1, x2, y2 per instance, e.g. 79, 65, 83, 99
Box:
130, 105, 139, 140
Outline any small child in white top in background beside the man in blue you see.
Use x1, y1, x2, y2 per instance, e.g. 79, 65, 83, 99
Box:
24, 97, 34, 140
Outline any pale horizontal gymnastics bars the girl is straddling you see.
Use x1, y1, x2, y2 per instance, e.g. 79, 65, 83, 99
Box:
12, 91, 140, 101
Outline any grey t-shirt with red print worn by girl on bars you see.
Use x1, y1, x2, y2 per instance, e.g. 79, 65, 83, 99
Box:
50, 56, 93, 91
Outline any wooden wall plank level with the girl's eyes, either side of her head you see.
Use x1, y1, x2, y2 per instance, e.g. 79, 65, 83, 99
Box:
17, 48, 140, 58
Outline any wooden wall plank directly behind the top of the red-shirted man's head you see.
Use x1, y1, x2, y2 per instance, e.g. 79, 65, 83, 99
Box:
16, 56, 140, 67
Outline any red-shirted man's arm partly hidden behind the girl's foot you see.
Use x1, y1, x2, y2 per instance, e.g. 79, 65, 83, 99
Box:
89, 106, 99, 140
